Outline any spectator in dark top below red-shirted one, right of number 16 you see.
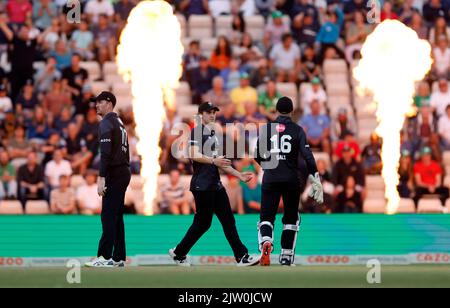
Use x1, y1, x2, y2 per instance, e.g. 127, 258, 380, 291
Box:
332, 146, 366, 196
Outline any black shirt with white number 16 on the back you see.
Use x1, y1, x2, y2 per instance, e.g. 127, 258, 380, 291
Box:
255, 116, 317, 186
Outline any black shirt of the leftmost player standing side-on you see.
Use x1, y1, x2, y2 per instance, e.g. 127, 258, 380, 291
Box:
98, 112, 130, 177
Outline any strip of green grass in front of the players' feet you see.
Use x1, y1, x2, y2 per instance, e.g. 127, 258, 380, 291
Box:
0, 265, 450, 288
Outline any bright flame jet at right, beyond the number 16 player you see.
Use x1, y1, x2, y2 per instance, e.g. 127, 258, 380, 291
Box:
353, 20, 432, 214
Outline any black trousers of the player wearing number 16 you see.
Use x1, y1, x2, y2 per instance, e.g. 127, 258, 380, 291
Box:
260, 182, 301, 249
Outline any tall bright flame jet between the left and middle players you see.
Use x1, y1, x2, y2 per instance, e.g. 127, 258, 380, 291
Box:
117, 1, 183, 215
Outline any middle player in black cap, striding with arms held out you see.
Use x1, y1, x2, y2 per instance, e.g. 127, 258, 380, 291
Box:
169, 102, 259, 266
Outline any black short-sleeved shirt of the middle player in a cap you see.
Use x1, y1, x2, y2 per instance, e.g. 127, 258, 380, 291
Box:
189, 124, 223, 191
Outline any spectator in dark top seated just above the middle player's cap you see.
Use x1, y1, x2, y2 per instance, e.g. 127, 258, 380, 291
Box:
188, 56, 218, 105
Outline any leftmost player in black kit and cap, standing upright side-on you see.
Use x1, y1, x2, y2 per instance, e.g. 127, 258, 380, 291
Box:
86, 91, 131, 267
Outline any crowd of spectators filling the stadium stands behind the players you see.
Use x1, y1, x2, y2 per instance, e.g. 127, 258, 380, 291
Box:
0, 0, 450, 214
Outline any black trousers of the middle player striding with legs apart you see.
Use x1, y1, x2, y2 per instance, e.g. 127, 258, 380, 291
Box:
175, 188, 248, 260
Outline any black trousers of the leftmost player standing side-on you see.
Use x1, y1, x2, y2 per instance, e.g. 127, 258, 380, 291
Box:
97, 166, 131, 262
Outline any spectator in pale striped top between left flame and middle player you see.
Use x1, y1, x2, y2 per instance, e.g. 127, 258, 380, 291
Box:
161, 170, 191, 215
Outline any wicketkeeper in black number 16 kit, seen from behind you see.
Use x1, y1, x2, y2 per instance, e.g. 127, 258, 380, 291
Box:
256, 97, 323, 266
